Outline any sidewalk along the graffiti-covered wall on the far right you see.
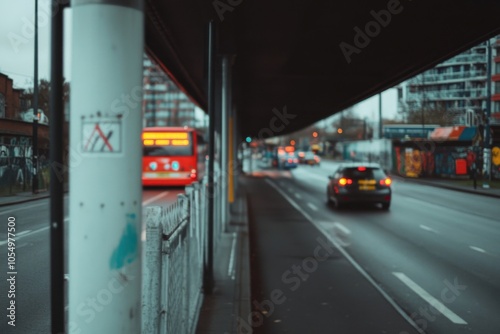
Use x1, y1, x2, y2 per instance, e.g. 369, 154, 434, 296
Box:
391, 174, 500, 198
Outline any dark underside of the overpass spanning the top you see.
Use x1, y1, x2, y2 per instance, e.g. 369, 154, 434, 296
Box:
145, 0, 500, 137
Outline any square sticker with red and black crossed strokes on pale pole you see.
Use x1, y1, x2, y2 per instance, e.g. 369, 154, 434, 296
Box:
82, 120, 122, 153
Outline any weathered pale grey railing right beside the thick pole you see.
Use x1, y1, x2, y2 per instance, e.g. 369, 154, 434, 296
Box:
142, 168, 224, 334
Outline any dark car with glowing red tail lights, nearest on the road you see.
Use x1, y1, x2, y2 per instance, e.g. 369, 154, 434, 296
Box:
327, 162, 392, 210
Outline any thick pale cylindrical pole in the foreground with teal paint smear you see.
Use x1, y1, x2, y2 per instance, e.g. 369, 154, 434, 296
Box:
68, 0, 144, 334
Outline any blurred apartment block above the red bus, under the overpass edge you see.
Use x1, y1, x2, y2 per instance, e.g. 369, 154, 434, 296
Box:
143, 55, 196, 127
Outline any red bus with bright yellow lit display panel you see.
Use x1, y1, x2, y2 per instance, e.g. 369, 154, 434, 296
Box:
142, 127, 203, 186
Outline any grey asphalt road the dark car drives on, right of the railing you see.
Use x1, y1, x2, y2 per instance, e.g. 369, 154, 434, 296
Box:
247, 162, 500, 334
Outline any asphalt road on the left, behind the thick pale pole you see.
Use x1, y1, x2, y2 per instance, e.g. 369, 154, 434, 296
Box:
0, 187, 184, 334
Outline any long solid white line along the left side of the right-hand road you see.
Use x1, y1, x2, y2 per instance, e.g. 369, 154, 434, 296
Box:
266, 179, 423, 333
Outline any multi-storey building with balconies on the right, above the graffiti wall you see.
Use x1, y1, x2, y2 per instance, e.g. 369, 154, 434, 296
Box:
398, 36, 500, 126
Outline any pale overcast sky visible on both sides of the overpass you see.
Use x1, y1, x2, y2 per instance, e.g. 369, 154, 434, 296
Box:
0, 0, 397, 118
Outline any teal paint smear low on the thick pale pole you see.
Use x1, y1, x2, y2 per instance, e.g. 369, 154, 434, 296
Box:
109, 213, 139, 269
